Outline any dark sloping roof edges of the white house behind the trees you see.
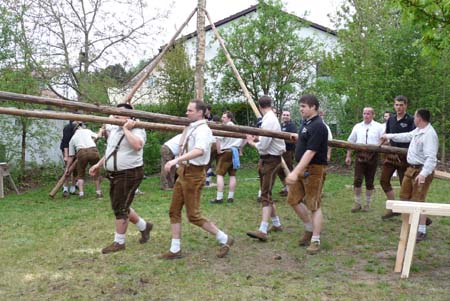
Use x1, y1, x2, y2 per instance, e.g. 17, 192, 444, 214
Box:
127, 5, 337, 85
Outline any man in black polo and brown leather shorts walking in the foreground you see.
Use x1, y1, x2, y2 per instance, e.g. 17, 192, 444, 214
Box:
286, 95, 328, 254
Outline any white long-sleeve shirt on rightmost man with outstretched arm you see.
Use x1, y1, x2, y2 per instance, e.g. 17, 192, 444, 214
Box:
386, 124, 439, 177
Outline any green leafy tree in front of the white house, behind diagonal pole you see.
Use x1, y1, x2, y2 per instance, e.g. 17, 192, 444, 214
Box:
210, 0, 319, 111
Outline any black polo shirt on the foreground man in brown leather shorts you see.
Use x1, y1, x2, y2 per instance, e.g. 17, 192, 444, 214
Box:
295, 115, 328, 165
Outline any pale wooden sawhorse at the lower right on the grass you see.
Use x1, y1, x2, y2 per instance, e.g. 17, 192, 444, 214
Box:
386, 200, 450, 278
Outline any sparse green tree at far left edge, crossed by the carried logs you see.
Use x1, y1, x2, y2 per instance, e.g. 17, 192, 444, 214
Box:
0, 4, 59, 175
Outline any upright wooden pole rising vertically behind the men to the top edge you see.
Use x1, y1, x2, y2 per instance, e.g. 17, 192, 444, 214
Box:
195, 0, 206, 100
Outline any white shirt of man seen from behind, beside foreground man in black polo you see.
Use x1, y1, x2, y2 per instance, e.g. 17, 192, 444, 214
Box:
255, 111, 286, 156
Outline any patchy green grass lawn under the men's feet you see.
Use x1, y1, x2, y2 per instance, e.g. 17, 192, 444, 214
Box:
0, 165, 450, 300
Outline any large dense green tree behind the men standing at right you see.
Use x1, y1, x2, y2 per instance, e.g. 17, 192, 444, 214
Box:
316, 0, 425, 135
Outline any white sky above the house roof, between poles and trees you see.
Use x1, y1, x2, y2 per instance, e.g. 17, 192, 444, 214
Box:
147, 0, 342, 51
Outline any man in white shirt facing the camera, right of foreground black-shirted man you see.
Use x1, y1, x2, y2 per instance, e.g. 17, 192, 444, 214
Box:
345, 107, 384, 213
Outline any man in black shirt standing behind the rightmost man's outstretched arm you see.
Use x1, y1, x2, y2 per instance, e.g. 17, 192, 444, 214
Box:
380, 95, 415, 219
